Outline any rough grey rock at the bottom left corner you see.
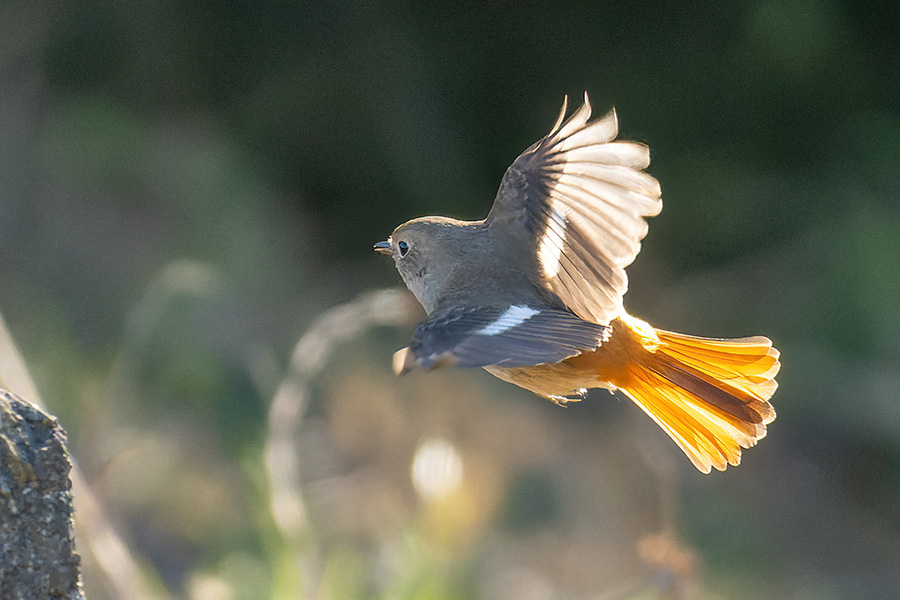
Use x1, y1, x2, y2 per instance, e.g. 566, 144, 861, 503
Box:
0, 390, 84, 600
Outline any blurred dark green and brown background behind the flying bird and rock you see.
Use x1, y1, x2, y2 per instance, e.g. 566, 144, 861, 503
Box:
0, 0, 900, 600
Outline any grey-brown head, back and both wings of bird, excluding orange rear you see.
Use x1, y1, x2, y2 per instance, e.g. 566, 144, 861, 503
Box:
376, 94, 662, 371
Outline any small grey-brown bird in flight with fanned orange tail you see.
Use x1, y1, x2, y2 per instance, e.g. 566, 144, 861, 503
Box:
374, 92, 781, 473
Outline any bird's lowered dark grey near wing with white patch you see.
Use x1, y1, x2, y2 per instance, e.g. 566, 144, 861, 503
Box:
394, 304, 606, 373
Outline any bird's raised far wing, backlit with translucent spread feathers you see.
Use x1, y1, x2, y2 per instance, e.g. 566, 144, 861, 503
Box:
485, 94, 662, 324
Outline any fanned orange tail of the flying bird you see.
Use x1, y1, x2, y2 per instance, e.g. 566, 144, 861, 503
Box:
611, 318, 780, 473
